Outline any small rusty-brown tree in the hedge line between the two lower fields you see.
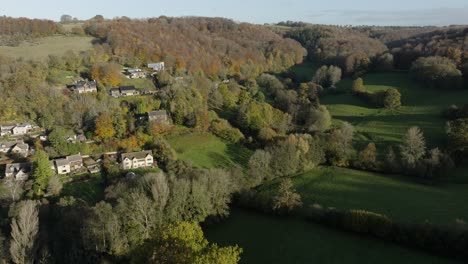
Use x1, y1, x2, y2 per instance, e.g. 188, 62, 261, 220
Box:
273, 178, 302, 213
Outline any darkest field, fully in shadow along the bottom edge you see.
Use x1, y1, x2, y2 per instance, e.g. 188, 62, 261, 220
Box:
205, 210, 456, 264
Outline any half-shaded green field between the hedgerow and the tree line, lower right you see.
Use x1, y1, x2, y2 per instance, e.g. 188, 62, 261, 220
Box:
261, 167, 468, 224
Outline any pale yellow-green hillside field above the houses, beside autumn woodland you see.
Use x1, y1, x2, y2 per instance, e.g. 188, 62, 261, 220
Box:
0, 36, 93, 60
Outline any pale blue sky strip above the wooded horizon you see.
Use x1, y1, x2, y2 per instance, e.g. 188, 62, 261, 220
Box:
0, 0, 468, 26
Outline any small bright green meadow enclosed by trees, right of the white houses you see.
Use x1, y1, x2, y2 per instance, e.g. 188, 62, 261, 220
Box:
168, 133, 252, 168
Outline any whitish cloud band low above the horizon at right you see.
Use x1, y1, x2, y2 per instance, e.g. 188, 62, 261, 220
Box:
308, 7, 468, 26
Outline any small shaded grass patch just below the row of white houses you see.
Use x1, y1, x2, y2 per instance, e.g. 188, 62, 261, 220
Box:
62, 173, 105, 205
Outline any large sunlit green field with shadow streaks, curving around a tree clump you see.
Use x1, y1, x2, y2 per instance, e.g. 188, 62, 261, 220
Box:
320, 73, 468, 150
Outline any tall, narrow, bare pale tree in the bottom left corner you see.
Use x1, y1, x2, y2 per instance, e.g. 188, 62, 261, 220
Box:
10, 200, 39, 264
